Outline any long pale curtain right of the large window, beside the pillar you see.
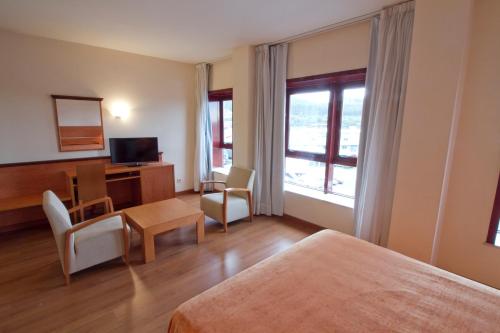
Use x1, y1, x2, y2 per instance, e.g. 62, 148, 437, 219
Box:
354, 2, 414, 246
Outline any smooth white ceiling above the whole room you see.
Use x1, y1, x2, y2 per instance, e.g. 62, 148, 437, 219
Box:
0, 0, 399, 63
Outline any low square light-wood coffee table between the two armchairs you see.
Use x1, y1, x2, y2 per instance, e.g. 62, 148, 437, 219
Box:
123, 198, 205, 263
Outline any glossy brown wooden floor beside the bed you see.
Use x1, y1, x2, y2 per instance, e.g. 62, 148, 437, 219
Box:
0, 195, 319, 332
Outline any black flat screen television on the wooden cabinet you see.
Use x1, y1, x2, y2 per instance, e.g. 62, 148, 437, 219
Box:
109, 138, 158, 165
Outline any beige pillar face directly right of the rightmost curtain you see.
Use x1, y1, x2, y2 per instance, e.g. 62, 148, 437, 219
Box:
388, 0, 471, 262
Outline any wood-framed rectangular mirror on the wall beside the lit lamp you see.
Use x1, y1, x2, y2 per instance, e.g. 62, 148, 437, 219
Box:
52, 95, 104, 151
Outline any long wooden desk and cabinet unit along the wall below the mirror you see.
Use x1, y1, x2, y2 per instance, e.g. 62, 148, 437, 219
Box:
0, 156, 170, 232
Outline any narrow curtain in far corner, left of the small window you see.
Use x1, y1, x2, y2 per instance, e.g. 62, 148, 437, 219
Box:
194, 63, 213, 191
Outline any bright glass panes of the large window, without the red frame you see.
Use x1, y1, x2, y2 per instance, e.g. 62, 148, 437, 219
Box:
285, 87, 365, 197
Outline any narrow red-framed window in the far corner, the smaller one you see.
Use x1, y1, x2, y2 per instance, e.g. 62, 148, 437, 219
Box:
208, 89, 233, 168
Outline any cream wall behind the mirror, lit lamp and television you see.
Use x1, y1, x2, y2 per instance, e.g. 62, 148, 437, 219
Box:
0, 31, 194, 191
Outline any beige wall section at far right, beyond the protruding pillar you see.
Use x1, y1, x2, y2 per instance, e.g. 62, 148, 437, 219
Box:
438, 0, 500, 288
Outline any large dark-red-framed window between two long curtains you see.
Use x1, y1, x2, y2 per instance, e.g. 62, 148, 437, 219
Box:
285, 69, 366, 198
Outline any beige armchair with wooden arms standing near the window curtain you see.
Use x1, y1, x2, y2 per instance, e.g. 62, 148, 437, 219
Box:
200, 167, 255, 232
